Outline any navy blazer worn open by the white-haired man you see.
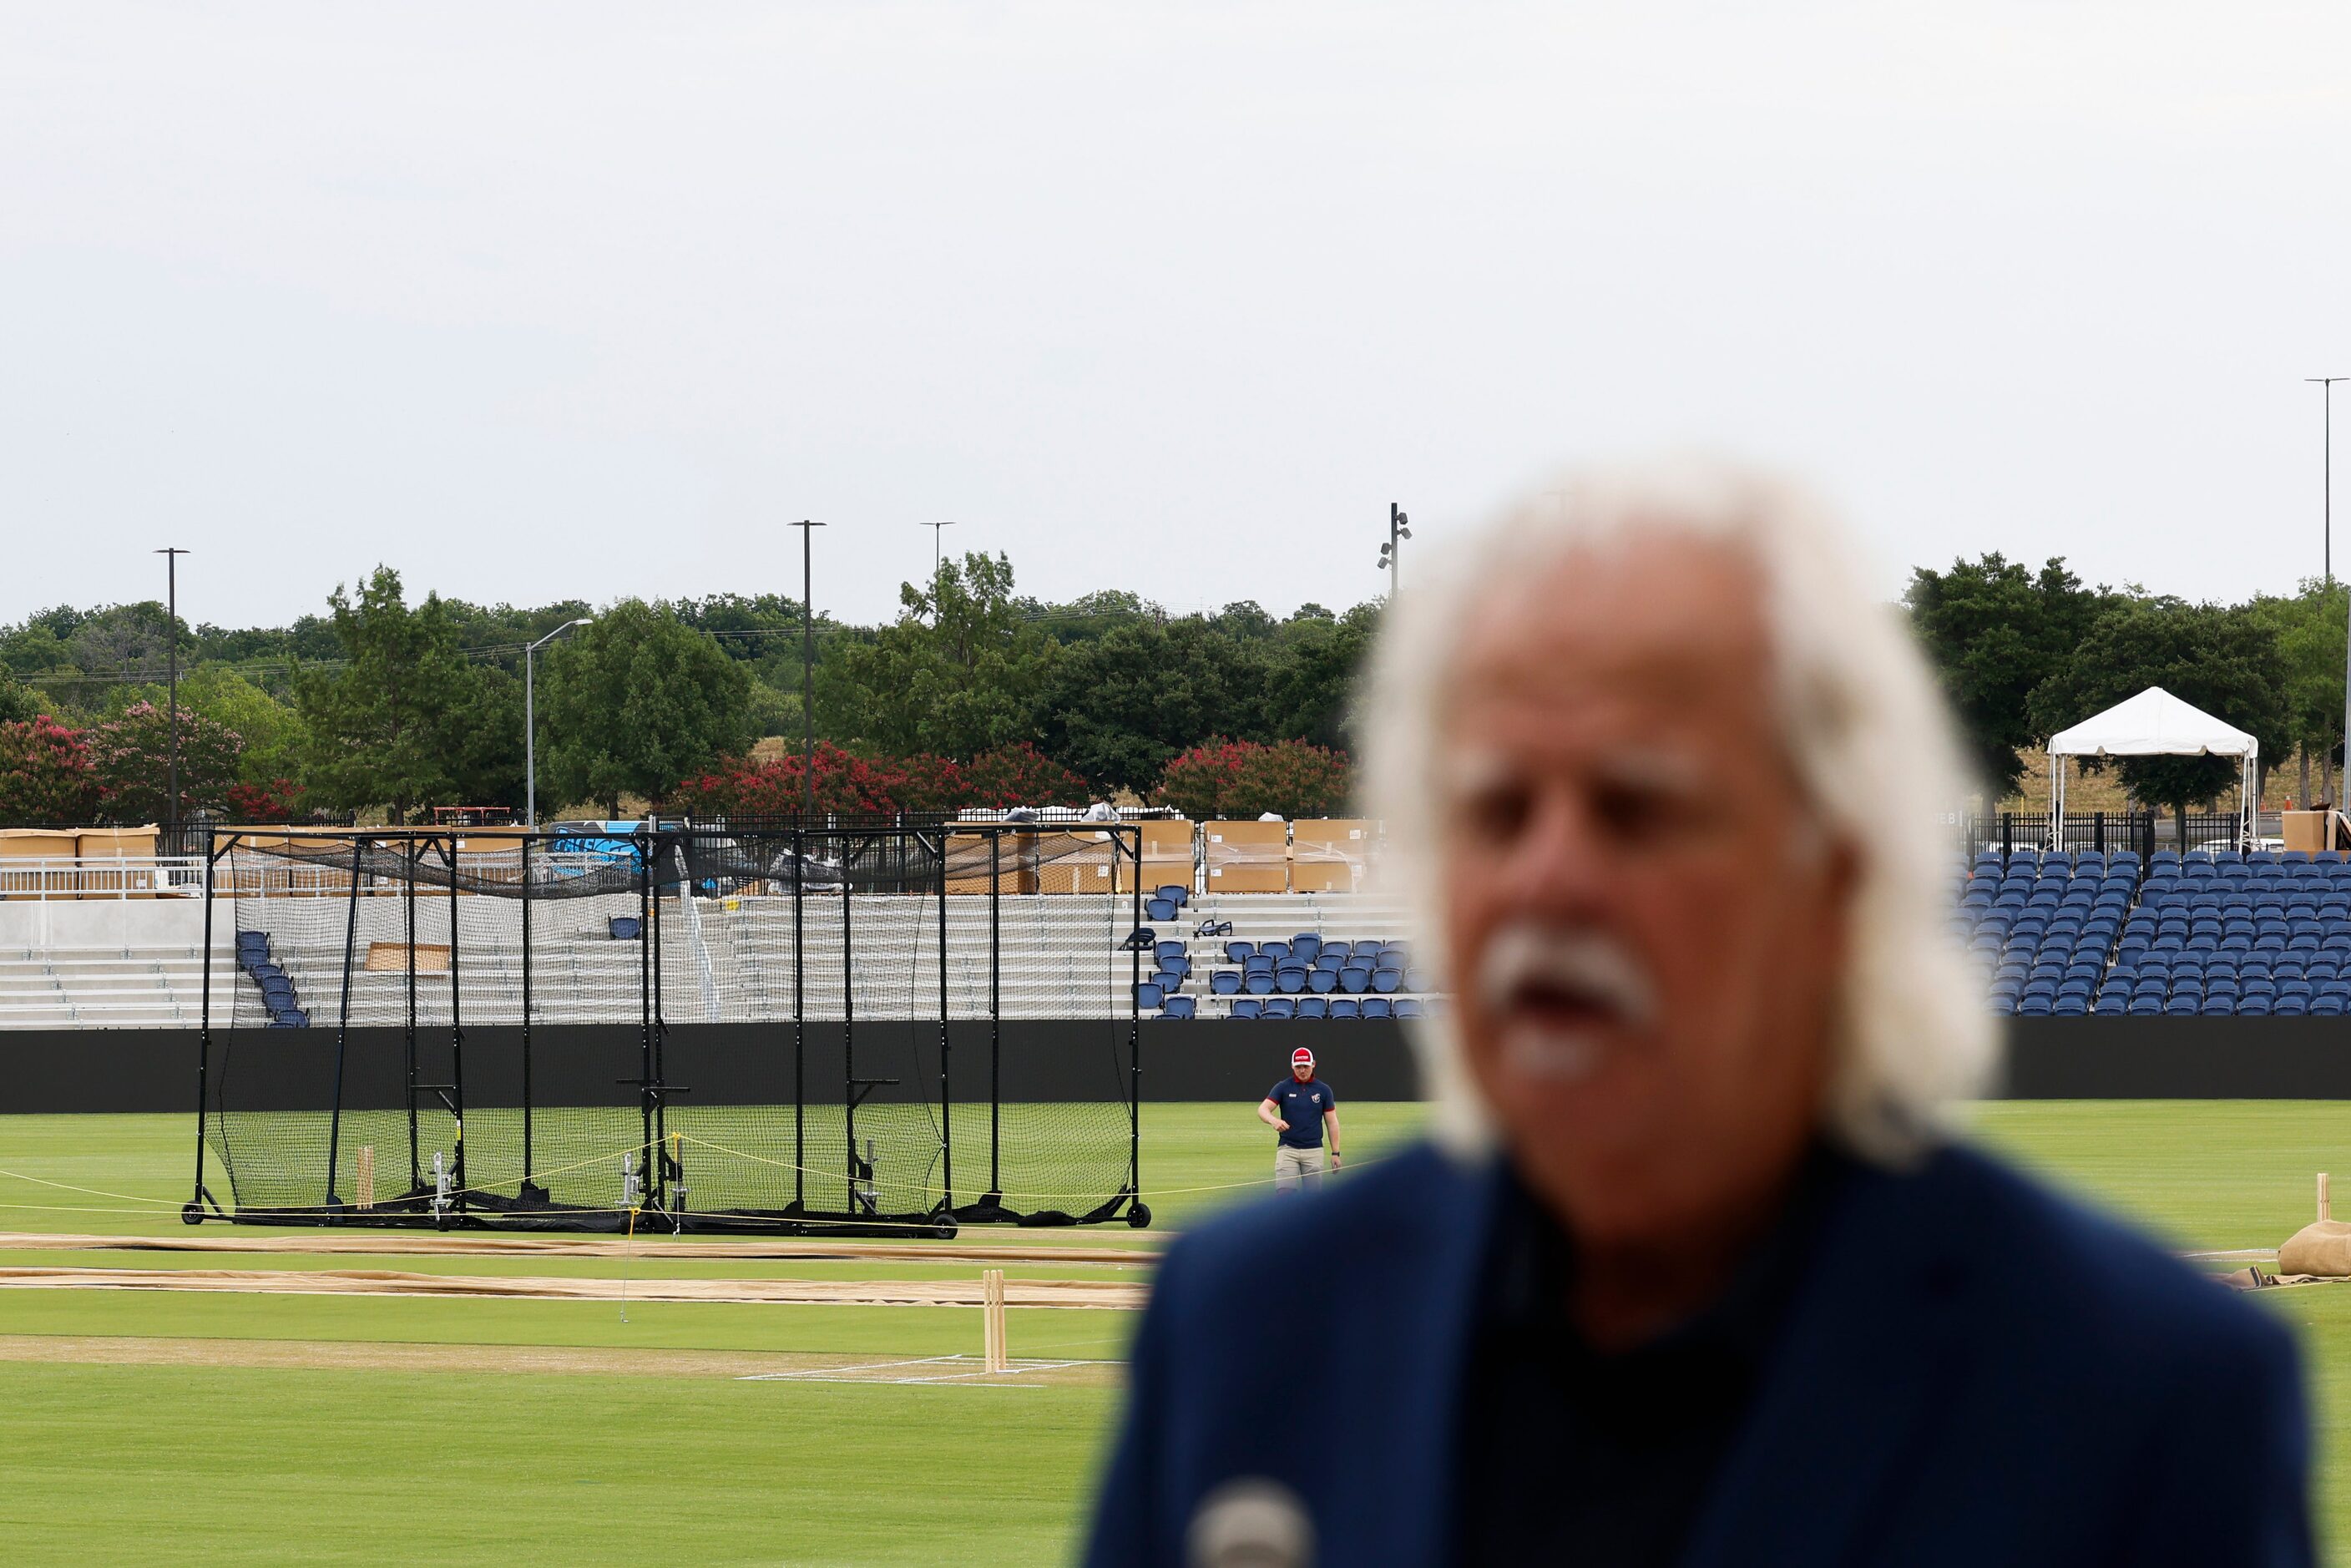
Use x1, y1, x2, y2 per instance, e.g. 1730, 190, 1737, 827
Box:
1086, 1145, 2311, 1568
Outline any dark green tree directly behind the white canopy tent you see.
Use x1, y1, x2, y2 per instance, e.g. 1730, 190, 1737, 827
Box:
2031, 597, 2293, 837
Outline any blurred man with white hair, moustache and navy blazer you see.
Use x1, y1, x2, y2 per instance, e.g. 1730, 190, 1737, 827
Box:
1089, 465, 2311, 1568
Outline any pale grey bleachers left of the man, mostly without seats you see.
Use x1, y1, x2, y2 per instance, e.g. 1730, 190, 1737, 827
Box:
0, 888, 1434, 1027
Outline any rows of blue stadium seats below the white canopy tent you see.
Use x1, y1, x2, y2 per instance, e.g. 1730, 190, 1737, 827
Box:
1954, 848, 2351, 1018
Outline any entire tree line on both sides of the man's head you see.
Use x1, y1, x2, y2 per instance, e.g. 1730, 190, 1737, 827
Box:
0, 554, 2346, 825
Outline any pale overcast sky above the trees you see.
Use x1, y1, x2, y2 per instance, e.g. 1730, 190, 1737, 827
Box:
0, 0, 2351, 625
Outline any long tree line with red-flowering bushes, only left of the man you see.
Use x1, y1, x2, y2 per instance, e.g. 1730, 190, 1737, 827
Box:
0, 554, 1378, 825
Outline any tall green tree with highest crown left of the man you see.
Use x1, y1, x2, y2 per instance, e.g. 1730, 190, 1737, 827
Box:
844, 554, 1055, 759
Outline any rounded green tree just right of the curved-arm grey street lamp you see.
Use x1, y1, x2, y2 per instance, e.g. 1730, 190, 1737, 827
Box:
538, 599, 750, 813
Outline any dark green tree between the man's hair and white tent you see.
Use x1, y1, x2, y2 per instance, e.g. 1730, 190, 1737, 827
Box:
1902, 554, 2114, 799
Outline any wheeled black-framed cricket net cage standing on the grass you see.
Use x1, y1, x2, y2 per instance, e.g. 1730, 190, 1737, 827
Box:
185, 822, 1150, 1234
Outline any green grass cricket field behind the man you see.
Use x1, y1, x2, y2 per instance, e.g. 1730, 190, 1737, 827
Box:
0, 1103, 2351, 1565
